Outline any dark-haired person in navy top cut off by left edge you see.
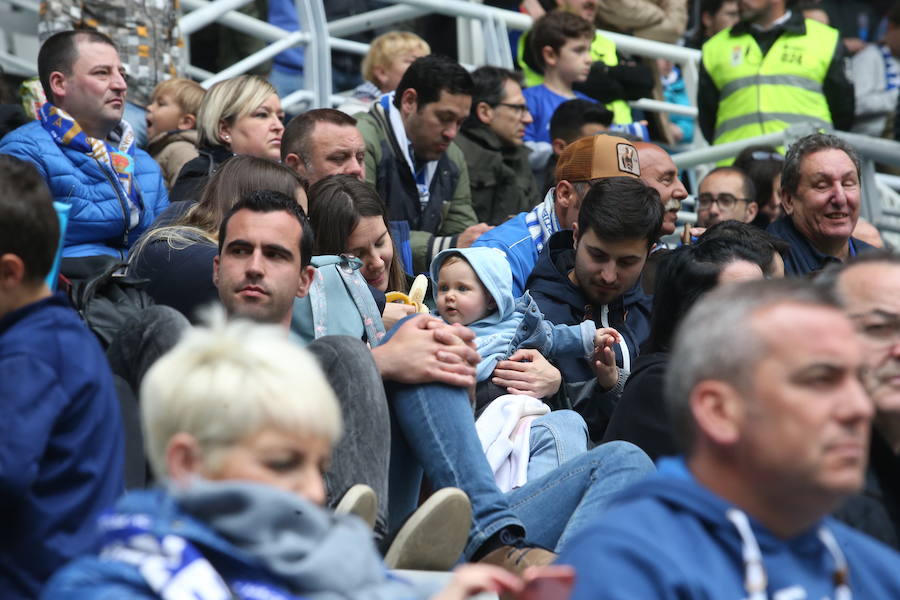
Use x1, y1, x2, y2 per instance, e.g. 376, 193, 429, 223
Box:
0, 156, 125, 599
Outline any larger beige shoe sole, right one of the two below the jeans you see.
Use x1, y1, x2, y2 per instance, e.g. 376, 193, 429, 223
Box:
384, 487, 472, 571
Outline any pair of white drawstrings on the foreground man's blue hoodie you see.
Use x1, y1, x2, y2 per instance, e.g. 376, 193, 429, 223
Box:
725, 508, 853, 600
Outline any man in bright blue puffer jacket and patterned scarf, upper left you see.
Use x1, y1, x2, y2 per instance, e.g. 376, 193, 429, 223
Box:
0, 30, 169, 258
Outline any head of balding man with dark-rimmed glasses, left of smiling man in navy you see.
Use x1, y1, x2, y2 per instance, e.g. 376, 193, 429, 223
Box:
697, 167, 759, 227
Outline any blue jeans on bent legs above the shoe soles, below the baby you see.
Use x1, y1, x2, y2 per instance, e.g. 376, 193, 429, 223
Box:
387, 370, 654, 558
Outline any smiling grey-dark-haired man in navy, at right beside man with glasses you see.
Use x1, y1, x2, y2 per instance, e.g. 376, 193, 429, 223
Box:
768, 133, 872, 275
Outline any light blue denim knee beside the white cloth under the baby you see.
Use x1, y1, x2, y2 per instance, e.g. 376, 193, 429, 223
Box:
528, 410, 588, 481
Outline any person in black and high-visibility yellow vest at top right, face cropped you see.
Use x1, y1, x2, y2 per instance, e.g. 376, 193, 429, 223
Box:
697, 0, 854, 151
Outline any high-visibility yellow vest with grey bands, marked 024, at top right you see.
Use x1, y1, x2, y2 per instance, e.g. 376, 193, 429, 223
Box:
703, 19, 838, 144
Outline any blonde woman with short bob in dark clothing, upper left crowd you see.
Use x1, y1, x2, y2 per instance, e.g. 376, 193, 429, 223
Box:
169, 75, 284, 203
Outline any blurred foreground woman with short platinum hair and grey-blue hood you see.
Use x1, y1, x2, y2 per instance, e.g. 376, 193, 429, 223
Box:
43, 317, 522, 600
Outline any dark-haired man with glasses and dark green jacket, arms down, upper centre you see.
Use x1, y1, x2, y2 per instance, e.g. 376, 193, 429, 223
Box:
456, 66, 540, 225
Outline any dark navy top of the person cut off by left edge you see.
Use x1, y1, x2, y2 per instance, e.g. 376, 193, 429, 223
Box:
0, 295, 124, 599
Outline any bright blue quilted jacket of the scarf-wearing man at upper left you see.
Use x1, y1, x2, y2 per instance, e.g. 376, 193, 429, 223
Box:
0, 121, 169, 258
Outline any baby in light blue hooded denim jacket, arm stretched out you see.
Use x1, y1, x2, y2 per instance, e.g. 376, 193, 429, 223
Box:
431, 247, 620, 381
